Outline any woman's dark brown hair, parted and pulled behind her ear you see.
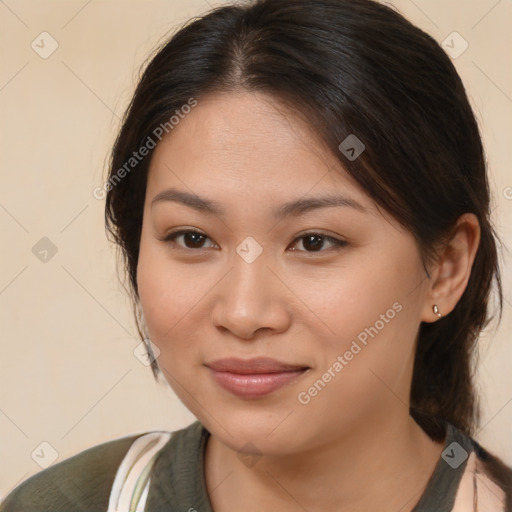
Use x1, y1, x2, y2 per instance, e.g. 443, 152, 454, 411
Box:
105, 0, 502, 444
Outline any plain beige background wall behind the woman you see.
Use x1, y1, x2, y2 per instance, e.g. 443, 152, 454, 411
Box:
0, 0, 512, 496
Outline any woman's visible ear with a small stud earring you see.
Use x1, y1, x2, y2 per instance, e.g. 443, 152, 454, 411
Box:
421, 213, 480, 322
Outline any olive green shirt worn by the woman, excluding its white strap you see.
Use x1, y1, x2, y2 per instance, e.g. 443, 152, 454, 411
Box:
0, 421, 508, 512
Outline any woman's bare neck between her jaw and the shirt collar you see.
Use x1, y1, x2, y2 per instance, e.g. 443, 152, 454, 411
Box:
205, 412, 443, 512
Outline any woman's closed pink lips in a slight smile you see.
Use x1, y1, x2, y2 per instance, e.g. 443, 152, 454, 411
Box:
205, 358, 310, 399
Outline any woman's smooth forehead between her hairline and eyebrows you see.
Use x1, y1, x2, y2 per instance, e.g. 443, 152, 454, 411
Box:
148, 93, 373, 213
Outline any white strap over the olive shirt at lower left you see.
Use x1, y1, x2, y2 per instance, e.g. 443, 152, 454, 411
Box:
107, 432, 172, 512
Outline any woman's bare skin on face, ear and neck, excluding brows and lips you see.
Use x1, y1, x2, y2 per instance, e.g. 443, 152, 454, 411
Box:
137, 92, 479, 512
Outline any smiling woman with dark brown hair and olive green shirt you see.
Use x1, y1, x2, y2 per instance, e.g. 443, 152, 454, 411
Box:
0, 0, 512, 512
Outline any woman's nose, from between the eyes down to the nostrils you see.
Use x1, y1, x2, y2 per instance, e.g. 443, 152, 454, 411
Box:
212, 247, 293, 341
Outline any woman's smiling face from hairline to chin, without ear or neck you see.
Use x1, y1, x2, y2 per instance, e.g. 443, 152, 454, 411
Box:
137, 93, 432, 454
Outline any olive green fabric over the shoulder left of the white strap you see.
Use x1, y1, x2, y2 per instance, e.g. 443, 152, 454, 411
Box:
0, 433, 150, 512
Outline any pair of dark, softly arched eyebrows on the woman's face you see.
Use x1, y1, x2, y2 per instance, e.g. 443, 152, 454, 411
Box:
151, 187, 366, 219
